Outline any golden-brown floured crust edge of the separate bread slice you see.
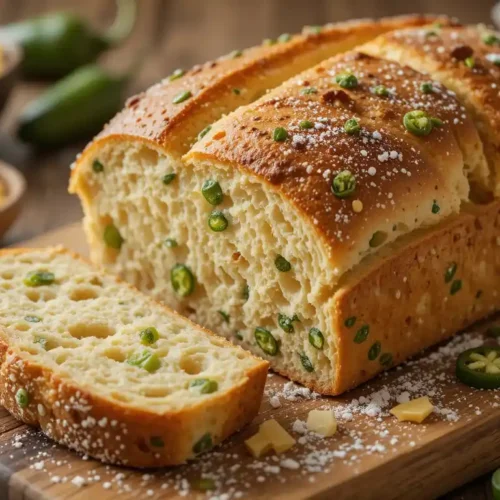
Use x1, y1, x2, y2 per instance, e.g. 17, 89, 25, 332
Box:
0, 249, 268, 467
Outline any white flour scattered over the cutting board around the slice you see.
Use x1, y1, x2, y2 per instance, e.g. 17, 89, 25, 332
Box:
0, 333, 500, 500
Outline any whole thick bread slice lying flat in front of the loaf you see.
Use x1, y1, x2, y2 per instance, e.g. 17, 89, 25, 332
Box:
0, 249, 267, 467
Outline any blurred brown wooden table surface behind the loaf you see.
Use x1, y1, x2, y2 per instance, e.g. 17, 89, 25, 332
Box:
0, 0, 494, 499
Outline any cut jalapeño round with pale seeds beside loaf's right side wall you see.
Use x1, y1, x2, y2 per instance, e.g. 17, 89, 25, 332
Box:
455, 346, 500, 389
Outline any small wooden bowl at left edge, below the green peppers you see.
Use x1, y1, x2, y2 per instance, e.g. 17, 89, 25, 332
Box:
0, 161, 26, 239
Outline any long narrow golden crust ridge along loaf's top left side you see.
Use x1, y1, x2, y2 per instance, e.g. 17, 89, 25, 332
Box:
75, 15, 451, 160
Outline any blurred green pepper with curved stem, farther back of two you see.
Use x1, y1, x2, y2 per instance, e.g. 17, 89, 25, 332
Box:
0, 0, 137, 79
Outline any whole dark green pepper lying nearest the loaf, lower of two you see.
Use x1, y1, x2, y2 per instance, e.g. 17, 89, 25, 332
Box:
17, 65, 128, 149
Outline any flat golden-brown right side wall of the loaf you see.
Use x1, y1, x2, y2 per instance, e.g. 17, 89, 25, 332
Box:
331, 202, 500, 394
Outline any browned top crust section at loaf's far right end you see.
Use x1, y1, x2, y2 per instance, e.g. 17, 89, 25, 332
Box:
360, 26, 500, 196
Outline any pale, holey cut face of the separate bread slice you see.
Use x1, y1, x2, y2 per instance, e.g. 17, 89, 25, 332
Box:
0, 249, 267, 414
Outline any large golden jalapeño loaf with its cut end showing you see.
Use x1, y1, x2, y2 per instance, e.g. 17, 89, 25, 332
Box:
71, 18, 500, 394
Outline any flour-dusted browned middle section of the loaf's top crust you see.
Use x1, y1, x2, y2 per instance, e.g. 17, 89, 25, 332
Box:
186, 52, 484, 273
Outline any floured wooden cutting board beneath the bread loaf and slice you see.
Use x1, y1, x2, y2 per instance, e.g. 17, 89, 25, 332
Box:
0, 224, 500, 500
